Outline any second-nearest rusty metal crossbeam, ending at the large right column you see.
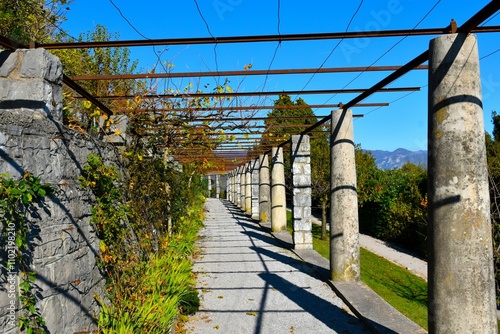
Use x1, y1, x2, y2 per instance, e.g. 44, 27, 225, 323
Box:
71, 65, 429, 81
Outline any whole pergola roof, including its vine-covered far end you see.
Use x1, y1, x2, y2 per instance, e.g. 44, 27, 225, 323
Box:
0, 1, 500, 169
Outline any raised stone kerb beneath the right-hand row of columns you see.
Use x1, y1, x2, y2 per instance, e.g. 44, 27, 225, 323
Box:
259, 219, 427, 334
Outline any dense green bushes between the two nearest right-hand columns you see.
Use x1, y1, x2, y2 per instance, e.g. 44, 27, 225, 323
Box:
356, 146, 427, 256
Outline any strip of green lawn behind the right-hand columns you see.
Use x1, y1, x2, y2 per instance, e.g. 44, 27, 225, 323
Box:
288, 213, 427, 330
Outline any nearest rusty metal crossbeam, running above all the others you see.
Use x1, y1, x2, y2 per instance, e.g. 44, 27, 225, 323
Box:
35, 26, 500, 50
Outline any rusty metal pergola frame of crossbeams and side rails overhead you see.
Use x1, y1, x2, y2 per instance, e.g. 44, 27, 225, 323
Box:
0, 1, 500, 167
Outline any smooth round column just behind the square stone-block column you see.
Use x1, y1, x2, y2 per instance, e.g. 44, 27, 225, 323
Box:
271, 147, 286, 232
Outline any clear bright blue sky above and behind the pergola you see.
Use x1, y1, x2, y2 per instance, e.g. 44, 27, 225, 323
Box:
63, 0, 500, 151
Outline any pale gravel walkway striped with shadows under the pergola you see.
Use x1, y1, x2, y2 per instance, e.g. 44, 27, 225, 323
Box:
185, 199, 428, 334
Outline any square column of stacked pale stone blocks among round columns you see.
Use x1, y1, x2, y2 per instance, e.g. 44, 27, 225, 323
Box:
291, 135, 313, 249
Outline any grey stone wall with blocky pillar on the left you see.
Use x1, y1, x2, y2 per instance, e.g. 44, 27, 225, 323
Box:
0, 49, 118, 333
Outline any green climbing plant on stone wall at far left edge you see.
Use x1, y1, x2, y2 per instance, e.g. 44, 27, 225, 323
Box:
0, 173, 52, 333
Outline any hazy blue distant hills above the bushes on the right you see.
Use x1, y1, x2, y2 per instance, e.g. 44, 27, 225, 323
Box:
368, 148, 427, 169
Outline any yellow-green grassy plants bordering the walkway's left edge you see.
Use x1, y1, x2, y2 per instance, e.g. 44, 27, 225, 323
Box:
95, 183, 204, 333
